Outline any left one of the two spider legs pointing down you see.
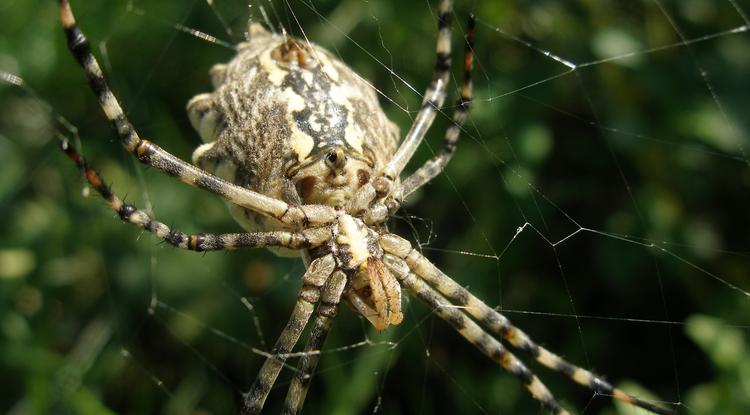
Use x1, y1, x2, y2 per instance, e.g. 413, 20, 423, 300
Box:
242, 254, 335, 415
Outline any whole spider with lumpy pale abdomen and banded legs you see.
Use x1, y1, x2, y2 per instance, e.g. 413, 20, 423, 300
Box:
59, 0, 669, 414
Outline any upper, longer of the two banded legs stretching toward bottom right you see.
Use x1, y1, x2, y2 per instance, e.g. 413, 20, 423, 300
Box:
381, 234, 669, 414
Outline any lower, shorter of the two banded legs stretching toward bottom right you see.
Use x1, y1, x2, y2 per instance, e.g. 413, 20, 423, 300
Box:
383, 254, 568, 415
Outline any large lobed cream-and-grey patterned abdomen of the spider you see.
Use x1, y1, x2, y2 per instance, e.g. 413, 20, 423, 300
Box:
188, 24, 399, 236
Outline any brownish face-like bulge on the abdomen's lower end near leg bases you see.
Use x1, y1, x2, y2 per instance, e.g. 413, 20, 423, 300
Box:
290, 146, 373, 207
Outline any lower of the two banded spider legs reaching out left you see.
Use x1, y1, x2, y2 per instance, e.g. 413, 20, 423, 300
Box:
60, 138, 332, 251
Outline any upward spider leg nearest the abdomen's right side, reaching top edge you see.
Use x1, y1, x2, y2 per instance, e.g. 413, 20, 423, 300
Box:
383, 0, 453, 180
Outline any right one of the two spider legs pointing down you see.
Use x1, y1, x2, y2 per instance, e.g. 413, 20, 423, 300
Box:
283, 271, 346, 415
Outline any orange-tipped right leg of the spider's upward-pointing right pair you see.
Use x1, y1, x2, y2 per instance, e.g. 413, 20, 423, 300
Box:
400, 14, 476, 199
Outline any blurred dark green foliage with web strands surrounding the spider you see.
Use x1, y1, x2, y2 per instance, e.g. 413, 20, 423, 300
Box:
0, 0, 750, 414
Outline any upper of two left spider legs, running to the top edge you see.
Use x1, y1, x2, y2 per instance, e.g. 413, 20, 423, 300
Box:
59, 0, 336, 226
